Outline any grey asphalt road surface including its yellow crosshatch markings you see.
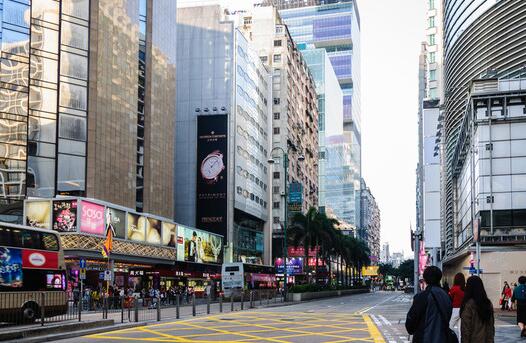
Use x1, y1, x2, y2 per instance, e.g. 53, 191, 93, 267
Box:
56, 292, 518, 343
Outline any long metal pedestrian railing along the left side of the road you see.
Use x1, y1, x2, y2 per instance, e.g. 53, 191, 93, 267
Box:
0, 290, 284, 326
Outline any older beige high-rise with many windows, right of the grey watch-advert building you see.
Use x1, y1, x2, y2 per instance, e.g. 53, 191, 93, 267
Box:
231, 6, 320, 257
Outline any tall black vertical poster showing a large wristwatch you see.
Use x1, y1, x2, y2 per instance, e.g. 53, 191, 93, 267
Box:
196, 115, 228, 237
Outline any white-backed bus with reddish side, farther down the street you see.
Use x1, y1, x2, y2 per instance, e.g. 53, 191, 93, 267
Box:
221, 262, 276, 297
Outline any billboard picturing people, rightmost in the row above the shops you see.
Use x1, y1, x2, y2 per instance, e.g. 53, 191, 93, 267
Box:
177, 225, 223, 263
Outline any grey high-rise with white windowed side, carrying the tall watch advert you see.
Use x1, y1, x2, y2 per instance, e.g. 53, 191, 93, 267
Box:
175, 6, 272, 263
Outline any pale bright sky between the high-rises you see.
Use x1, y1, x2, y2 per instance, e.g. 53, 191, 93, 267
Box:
178, 0, 427, 256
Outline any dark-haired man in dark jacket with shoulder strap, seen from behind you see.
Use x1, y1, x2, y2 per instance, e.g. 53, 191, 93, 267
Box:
405, 266, 452, 343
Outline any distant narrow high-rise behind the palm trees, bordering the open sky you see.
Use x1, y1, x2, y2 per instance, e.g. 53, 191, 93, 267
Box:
358, 180, 380, 263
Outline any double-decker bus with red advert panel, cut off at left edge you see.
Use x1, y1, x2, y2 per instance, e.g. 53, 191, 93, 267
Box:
0, 223, 68, 322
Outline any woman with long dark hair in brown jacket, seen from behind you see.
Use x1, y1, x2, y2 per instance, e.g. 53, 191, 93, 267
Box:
460, 275, 495, 343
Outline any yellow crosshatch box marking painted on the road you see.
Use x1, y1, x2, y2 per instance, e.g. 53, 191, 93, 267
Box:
87, 311, 385, 343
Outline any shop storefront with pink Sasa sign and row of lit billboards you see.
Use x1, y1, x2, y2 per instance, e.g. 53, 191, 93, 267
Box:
24, 197, 223, 295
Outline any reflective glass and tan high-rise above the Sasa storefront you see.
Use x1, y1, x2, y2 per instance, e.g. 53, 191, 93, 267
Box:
0, 0, 176, 217
